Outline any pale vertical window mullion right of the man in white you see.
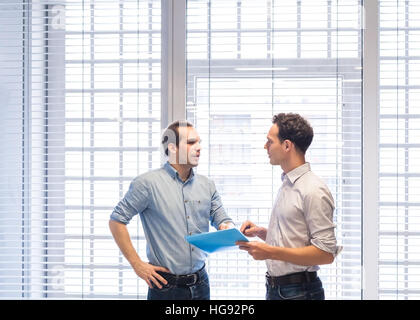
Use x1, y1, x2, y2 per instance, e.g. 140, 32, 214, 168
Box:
362, 0, 379, 300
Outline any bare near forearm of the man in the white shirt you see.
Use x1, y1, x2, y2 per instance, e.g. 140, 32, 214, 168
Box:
268, 245, 334, 266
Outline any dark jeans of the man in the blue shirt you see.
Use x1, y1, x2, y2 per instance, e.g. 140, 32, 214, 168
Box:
147, 269, 210, 300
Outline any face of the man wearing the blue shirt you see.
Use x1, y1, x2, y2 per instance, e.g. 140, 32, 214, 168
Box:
177, 127, 201, 167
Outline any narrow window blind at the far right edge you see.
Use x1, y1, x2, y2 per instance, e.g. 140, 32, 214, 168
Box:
378, 0, 420, 299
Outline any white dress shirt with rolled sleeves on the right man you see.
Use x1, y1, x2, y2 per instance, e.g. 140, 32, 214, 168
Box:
266, 163, 342, 276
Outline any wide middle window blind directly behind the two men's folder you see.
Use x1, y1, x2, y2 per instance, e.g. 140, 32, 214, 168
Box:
186, 0, 363, 299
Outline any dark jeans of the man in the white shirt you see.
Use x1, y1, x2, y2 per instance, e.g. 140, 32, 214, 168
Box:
265, 277, 325, 300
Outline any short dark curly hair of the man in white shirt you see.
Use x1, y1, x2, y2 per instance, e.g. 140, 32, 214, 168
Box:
273, 113, 314, 154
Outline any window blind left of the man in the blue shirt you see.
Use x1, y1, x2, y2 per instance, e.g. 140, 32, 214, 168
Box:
0, 0, 161, 299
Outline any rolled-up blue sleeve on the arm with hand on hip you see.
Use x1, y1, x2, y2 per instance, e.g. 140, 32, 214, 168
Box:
111, 180, 149, 224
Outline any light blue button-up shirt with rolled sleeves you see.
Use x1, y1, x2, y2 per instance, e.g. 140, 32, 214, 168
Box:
111, 162, 232, 274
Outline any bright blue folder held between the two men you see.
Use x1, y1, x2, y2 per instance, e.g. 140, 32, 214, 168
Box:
185, 228, 248, 253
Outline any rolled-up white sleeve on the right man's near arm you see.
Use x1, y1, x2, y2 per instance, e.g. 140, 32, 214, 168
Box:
304, 188, 342, 257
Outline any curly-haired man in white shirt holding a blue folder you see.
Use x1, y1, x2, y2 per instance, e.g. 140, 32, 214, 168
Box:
237, 113, 341, 300
